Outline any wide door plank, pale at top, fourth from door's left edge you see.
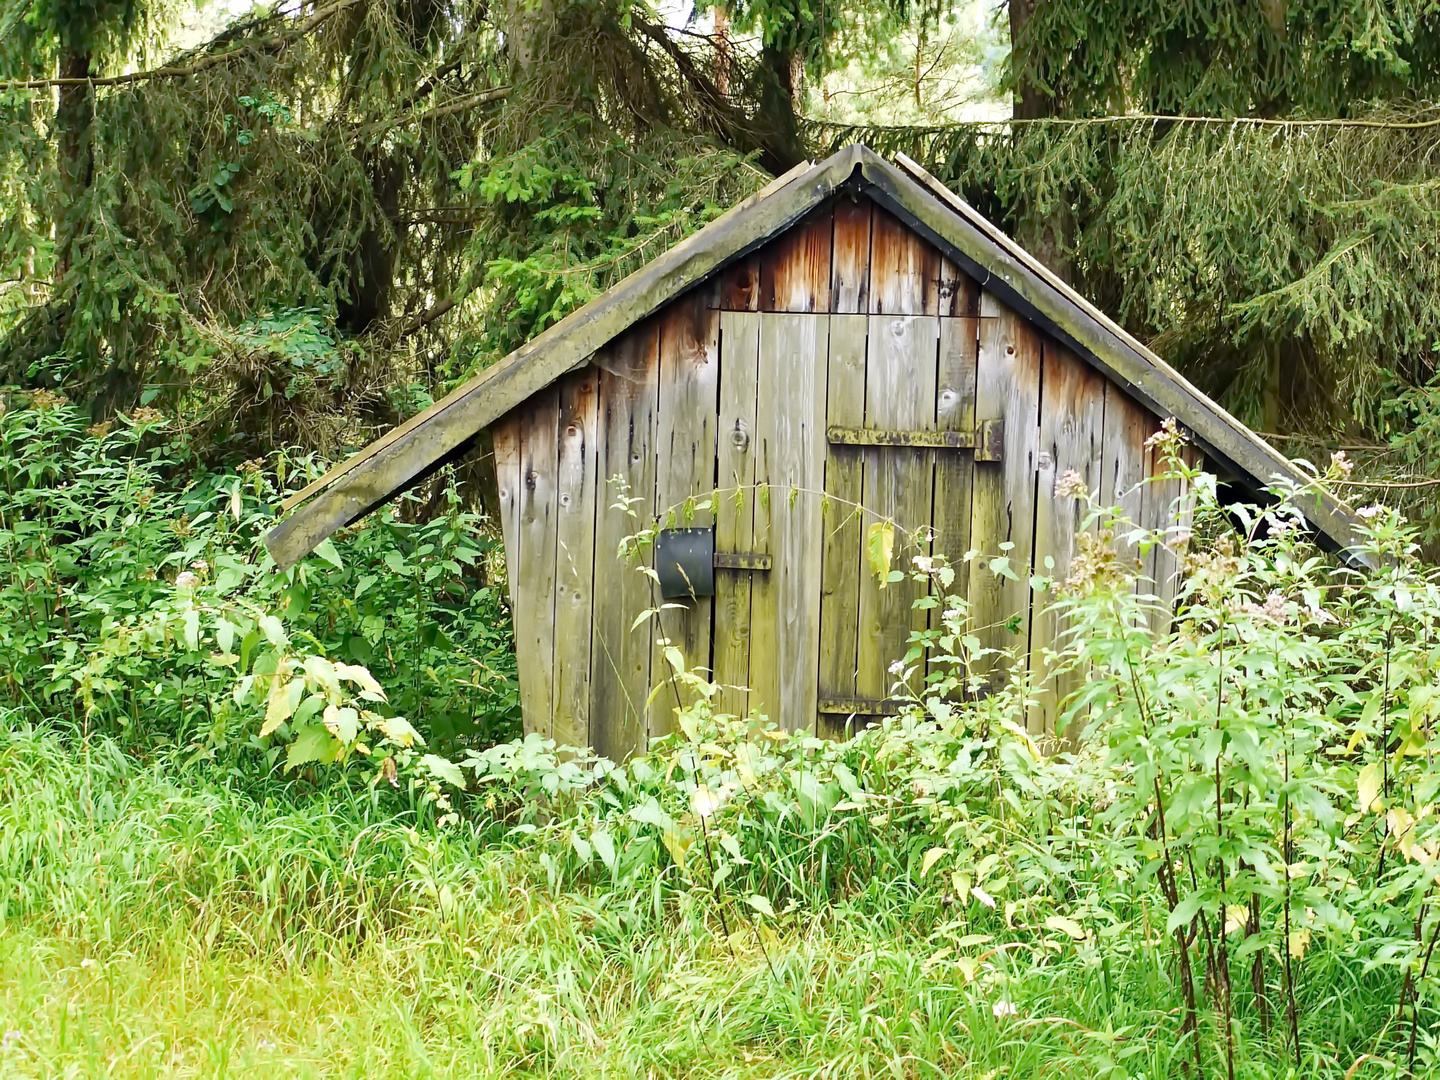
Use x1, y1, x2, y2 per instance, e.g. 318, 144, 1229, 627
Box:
855, 312, 940, 698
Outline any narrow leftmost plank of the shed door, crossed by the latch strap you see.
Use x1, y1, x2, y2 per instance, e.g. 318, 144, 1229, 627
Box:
714, 311, 760, 716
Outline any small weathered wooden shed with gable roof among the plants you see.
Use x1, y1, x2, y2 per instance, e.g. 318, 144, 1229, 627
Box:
266, 147, 1354, 757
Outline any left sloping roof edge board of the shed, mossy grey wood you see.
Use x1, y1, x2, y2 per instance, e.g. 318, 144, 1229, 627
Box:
265, 147, 863, 569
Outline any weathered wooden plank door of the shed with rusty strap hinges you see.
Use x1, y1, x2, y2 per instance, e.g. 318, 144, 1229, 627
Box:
713, 311, 976, 733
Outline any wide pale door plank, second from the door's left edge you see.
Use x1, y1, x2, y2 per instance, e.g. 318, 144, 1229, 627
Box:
750, 314, 829, 730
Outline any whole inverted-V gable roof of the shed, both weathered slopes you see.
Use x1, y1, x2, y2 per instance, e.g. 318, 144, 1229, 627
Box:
265, 145, 1365, 567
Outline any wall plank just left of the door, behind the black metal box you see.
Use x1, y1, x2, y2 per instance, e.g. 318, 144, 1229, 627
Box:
649, 288, 720, 739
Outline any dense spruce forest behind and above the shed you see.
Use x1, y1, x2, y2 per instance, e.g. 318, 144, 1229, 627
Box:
0, 0, 1440, 540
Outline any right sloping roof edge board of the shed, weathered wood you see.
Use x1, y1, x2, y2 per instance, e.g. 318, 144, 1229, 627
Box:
860, 150, 1372, 564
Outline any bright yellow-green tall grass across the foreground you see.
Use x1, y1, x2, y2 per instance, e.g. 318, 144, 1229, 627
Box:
0, 727, 1416, 1079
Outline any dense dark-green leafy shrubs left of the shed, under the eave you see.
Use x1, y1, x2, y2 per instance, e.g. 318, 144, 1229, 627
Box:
0, 392, 518, 766
